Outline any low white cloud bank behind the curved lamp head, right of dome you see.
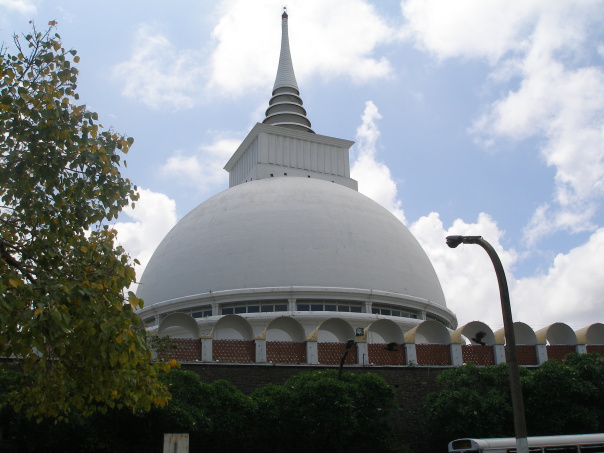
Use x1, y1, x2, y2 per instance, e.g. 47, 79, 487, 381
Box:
410, 212, 604, 329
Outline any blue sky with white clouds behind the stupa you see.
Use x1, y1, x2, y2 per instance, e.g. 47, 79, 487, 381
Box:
0, 0, 604, 330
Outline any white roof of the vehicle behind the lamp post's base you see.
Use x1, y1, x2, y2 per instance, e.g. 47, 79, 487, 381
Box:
449, 433, 604, 453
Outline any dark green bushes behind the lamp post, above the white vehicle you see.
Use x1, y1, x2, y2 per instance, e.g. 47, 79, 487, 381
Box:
424, 354, 604, 448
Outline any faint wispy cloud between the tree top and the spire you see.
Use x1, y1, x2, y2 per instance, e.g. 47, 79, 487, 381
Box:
113, 24, 203, 110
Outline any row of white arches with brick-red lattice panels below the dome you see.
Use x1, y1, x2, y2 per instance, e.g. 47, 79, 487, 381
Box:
157, 313, 604, 366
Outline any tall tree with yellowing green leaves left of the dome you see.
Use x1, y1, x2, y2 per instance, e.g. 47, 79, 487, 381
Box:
0, 22, 170, 420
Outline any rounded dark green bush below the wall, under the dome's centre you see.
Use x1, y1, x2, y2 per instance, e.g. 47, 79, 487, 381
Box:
252, 370, 395, 452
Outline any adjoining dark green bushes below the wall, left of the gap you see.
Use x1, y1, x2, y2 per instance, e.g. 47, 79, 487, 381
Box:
155, 370, 395, 453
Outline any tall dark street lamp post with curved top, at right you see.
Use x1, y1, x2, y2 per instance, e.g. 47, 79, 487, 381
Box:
447, 236, 528, 453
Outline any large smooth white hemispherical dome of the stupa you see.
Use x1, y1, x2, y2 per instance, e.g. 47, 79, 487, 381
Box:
137, 177, 446, 311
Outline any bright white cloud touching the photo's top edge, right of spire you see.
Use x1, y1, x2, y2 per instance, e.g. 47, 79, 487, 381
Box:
401, 0, 602, 64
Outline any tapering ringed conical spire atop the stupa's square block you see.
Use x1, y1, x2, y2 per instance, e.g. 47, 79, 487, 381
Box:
262, 8, 314, 133
